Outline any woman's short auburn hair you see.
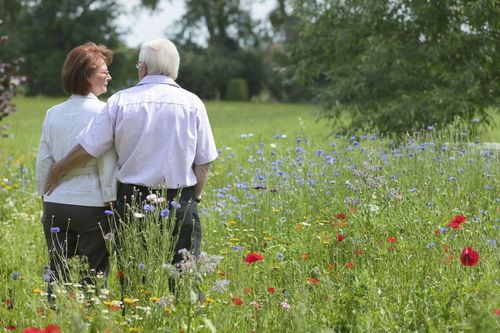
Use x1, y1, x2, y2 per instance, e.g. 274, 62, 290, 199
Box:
61, 42, 113, 95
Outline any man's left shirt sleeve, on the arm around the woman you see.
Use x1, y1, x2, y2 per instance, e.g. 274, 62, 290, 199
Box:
76, 103, 116, 157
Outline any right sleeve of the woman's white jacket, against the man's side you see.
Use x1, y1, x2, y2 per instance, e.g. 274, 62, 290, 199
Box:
97, 147, 118, 202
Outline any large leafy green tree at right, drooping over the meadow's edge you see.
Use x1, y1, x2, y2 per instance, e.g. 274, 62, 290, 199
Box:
289, 0, 500, 133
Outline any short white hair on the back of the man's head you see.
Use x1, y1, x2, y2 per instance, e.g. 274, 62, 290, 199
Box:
139, 38, 180, 80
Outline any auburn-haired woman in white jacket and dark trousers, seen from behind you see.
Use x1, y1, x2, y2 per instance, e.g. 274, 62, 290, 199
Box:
36, 42, 117, 299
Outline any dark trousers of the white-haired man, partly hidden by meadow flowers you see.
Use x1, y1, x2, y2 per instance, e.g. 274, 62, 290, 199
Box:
116, 183, 201, 264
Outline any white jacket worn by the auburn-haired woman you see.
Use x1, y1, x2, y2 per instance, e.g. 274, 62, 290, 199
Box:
36, 93, 117, 207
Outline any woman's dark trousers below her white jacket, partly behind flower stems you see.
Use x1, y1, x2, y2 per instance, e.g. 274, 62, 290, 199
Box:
42, 202, 110, 293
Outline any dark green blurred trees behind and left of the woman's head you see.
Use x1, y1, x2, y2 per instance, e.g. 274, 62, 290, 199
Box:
4, 0, 126, 95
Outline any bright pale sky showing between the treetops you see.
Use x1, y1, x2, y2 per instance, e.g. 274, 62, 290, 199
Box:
118, 0, 274, 47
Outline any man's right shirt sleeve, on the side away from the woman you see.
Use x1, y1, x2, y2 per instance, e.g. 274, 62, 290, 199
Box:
194, 104, 218, 165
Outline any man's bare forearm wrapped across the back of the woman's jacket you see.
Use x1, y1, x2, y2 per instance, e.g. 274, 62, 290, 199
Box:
45, 144, 93, 194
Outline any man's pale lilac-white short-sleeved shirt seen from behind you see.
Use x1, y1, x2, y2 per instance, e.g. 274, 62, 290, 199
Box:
77, 75, 217, 188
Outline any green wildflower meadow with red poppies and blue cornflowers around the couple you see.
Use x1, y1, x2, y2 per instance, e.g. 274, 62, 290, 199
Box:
0, 97, 500, 332
